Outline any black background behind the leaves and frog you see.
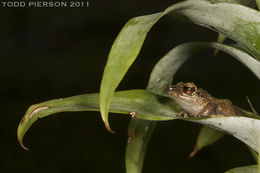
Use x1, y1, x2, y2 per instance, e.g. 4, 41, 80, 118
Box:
0, 0, 260, 173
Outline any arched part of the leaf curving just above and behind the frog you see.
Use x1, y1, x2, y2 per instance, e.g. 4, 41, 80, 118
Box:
146, 42, 260, 80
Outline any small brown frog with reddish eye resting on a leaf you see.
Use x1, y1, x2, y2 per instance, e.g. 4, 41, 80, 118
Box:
165, 82, 246, 118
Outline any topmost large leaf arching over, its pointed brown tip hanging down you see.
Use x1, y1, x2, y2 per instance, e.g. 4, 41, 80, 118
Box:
100, 0, 260, 134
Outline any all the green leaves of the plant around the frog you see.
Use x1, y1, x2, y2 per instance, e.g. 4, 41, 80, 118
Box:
17, 0, 260, 173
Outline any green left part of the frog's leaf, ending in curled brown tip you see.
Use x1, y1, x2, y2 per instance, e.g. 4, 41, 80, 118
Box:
17, 90, 180, 148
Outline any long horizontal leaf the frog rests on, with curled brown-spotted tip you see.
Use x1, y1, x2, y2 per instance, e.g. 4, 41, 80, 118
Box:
17, 90, 260, 151
